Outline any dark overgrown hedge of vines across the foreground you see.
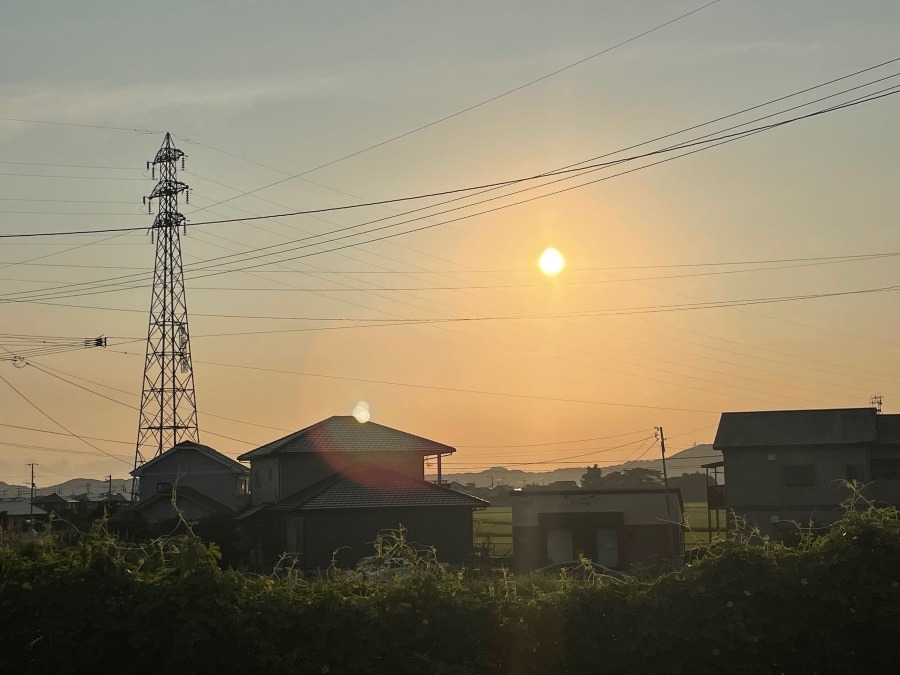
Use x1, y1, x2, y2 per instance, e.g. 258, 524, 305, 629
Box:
0, 494, 900, 673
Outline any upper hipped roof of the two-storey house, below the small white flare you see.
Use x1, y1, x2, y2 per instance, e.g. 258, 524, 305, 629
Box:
238, 415, 455, 460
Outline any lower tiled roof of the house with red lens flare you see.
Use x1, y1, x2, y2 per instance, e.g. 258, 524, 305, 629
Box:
274, 464, 490, 511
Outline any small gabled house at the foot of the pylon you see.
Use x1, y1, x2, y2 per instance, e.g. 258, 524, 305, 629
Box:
131, 441, 250, 523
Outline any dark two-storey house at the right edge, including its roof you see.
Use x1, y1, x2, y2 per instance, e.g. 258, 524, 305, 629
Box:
713, 408, 900, 535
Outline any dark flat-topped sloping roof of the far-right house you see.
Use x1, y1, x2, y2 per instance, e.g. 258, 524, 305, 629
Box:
713, 408, 878, 450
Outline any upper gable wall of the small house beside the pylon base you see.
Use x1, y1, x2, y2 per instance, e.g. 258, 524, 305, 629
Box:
139, 449, 242, 509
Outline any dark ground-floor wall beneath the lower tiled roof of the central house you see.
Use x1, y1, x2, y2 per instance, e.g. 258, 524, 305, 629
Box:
278, 507, 472, 570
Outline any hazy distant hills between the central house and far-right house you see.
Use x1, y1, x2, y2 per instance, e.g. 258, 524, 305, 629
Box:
426, 444, 722, 487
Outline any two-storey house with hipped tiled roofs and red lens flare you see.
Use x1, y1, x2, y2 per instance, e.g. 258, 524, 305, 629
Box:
239, 416, 488, 570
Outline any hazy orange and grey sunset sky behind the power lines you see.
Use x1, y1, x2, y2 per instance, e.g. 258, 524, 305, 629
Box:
0, 0, 900, 486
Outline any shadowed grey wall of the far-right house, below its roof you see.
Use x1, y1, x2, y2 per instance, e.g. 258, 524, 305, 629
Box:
722, 446, 874, 536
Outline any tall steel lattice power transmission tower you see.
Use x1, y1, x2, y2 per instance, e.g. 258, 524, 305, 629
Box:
132, 133, 200, 499
